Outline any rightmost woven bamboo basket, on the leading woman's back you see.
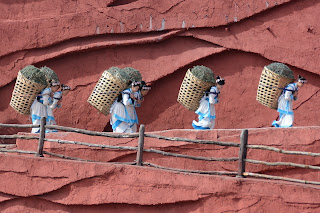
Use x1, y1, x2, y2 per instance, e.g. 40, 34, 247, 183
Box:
256, 67, 294, 109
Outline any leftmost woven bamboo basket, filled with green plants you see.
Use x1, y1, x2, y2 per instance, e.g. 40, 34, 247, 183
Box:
10, 71, 46, 114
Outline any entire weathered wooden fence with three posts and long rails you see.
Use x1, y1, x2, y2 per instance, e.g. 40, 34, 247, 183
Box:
0, 118, 320, 185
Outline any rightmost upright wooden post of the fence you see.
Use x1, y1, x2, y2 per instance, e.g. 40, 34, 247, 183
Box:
236, 129, 248, 178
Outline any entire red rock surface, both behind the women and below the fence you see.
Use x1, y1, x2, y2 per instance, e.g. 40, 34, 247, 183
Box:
0, 0, 320, 212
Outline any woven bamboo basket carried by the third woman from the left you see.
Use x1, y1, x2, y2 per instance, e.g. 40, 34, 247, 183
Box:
177, 69, 215, 111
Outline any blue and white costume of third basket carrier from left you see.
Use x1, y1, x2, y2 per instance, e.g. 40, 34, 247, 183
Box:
192, 86, 220, 129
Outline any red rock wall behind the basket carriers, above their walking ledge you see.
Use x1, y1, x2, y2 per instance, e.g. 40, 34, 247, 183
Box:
0, 0, 320, 134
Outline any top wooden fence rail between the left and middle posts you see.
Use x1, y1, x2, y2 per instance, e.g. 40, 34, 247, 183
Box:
46, 125, 139, 138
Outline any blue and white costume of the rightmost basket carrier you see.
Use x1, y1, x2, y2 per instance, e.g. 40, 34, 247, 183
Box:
272, 83, 298, 127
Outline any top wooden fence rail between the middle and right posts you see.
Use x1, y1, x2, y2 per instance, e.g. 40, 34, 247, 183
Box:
144, 134, 240, 147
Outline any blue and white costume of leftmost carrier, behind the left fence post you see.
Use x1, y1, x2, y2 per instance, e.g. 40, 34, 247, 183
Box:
30, 88, 52, 133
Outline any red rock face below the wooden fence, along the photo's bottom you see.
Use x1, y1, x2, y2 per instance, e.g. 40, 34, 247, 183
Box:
0, 154, 320, 212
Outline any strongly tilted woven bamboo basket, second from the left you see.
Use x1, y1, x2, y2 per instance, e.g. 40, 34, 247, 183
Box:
88, 70, 128, 115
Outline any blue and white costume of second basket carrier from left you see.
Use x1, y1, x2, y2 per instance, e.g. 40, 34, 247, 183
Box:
110, 89, 141, 133
